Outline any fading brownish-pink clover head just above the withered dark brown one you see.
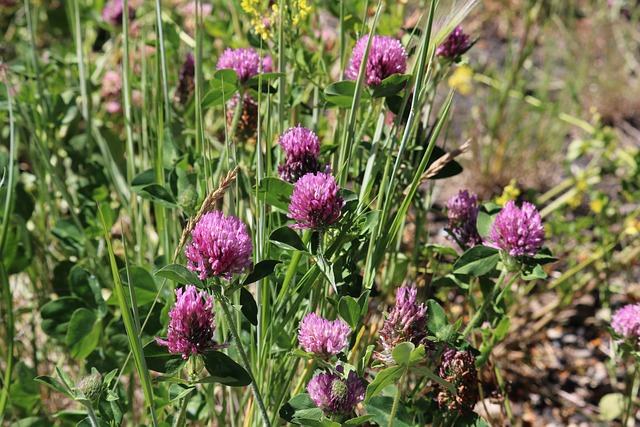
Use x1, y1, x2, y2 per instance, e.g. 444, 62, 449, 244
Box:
374, 286, 431, 364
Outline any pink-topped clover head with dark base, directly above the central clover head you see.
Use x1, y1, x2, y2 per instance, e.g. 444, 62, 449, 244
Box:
278, 125, 320, 183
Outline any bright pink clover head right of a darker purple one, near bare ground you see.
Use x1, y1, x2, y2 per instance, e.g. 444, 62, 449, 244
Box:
484, 200, 544, 257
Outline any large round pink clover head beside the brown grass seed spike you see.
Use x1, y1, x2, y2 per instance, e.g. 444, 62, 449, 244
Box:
185, 211, 253, 280
